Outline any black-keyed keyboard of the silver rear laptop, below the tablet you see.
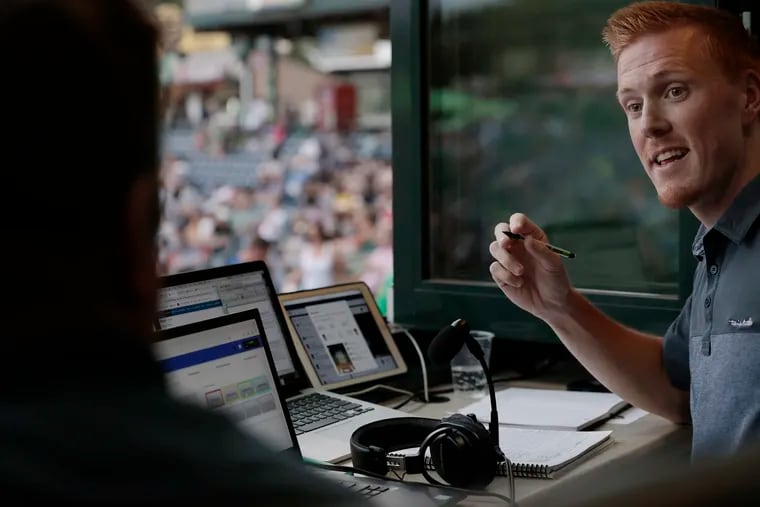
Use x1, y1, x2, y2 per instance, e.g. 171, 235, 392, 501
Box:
288, 393, 374, 435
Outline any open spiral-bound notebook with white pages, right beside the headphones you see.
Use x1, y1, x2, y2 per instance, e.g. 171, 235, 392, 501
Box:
425, 426, 612, 479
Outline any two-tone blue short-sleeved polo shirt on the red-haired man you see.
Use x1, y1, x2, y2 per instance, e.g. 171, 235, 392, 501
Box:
664, 176, 760, 458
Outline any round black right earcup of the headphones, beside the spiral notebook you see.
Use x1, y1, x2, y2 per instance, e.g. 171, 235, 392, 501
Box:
430, 414, 496, 489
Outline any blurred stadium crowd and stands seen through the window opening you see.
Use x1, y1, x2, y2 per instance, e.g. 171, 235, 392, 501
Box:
156, 0, 393, 306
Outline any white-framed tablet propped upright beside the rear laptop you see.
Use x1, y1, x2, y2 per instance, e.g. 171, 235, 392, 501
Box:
280, 283, 406, 387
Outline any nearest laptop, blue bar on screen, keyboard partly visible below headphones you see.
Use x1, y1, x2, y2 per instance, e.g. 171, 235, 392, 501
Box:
153, 308, 465, 507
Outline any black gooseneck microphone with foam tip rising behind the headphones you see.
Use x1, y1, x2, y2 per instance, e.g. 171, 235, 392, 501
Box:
428, 319, 504, 460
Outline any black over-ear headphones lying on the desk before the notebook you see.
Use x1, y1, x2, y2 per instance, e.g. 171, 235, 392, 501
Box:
351, 414, 504, 489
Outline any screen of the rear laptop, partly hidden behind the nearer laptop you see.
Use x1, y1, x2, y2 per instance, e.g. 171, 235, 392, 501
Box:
155, 261, 302, 390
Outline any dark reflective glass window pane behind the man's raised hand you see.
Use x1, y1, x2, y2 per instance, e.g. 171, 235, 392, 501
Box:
427, 0, 700, 295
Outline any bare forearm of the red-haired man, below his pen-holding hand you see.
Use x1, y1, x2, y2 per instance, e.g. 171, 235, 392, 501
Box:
547, 291, 689, 423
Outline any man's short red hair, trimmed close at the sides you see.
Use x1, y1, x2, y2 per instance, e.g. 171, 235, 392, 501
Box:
602, 1, 760, 77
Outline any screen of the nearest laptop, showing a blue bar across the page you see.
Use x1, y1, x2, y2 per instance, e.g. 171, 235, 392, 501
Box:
153, 310, 298, 452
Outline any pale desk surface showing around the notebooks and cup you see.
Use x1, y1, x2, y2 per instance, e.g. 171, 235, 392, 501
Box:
360, 381, 691, 507
